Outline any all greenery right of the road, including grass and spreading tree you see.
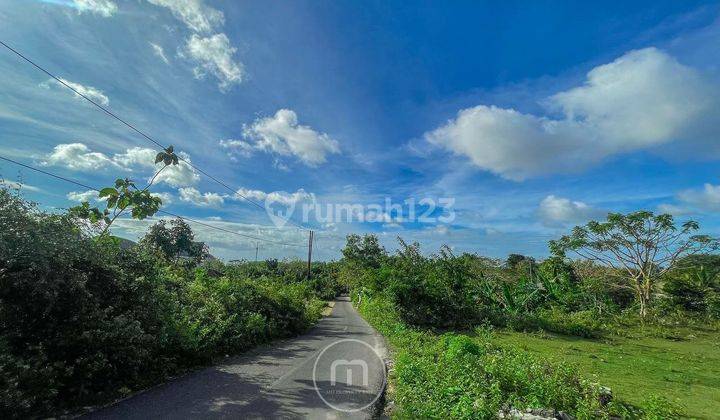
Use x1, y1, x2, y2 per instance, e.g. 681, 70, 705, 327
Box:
340, 212, 720, 419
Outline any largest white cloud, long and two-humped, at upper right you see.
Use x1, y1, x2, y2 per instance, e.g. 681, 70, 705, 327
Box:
425, 48, 720, 180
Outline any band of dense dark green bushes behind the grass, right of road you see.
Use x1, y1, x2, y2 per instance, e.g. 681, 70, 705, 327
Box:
339, 235, 720, 337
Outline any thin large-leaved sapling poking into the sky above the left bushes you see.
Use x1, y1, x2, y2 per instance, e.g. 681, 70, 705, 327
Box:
69, 146, 179, 236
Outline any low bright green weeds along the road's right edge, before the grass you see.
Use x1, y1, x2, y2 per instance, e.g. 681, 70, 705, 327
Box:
359, 296, 605, 419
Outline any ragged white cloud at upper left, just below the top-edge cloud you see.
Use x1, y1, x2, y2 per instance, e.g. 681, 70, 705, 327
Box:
181, 33, 245, 92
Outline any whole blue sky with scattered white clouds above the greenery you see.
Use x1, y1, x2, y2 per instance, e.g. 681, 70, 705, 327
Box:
0, 0, 720, 259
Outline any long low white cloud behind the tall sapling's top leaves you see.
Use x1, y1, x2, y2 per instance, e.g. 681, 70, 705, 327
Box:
41, 143, 200, 187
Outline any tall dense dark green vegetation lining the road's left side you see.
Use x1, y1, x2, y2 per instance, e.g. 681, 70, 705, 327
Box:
0, 189, 339, 418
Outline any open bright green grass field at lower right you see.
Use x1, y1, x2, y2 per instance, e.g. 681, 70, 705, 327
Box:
494, 330, 720, 419
